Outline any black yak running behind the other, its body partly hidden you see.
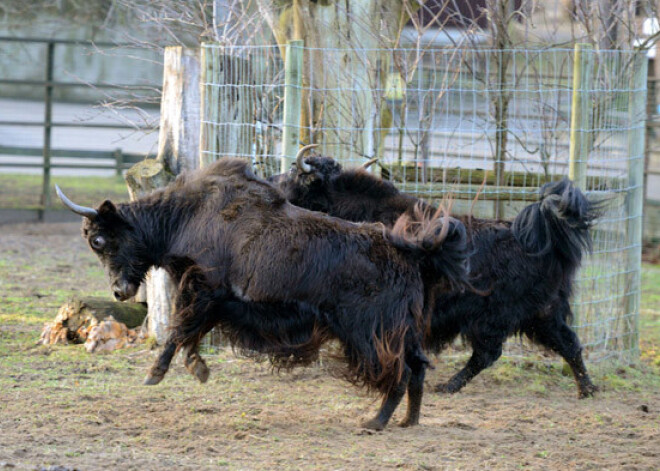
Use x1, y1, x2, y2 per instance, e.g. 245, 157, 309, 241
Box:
269, 152, 599, 398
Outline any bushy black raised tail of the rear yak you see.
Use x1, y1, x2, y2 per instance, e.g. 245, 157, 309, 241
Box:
512, 177, 602, 268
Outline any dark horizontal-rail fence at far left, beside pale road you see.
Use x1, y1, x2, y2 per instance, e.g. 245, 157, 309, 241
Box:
0, 36, 161, 214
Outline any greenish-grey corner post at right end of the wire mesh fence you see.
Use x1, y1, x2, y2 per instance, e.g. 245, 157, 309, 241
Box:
624, 52, 648, 358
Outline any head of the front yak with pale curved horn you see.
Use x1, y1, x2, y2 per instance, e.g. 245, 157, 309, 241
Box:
55, 185, 154, 301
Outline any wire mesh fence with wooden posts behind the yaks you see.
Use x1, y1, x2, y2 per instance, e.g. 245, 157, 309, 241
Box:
201, 42, 647, 362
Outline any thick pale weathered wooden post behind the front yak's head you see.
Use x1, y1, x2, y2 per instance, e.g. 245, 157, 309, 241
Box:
126, 46, 200, 343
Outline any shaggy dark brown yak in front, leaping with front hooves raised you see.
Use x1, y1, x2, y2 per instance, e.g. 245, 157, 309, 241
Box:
58, 158, 466, 429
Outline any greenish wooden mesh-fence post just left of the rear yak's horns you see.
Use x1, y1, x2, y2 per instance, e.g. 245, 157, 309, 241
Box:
280, 41, 304, 173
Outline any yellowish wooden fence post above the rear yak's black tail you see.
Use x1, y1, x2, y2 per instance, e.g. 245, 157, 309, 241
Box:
568, 43, 594, 190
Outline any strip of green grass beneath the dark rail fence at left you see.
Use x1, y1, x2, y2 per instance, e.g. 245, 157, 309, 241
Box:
0, 175, 128, 209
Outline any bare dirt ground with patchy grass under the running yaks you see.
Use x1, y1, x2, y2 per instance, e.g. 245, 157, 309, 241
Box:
0, 224, 660, 470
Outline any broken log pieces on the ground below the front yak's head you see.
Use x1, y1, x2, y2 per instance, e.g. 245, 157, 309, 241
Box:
39, 298, 147, 353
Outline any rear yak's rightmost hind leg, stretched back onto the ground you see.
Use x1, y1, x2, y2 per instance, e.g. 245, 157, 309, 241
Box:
528, 312, 598, 399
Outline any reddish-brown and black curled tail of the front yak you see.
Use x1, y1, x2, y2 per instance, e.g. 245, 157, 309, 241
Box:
390, 202, 471, 290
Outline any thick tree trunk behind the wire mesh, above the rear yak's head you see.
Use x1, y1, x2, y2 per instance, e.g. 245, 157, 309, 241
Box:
257, 0, 419, 163
